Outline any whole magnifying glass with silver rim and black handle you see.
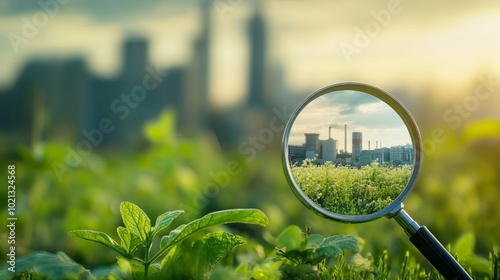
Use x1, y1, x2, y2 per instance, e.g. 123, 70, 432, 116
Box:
282, 83, 472, 279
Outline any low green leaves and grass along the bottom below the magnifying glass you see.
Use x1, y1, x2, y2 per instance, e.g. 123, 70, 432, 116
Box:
231, 226, 500, 280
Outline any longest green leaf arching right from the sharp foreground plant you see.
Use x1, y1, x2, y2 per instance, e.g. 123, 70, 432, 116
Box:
153, 209, 268, 260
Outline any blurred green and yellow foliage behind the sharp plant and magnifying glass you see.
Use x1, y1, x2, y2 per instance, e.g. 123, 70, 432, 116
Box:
0, 111, 500, 279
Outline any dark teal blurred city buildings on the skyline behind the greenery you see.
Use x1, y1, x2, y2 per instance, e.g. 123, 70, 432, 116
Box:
0, 1, 290, 151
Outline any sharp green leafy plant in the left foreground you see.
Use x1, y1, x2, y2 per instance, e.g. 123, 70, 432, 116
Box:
69, 202, 268, 279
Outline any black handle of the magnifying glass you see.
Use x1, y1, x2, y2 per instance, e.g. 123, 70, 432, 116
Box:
394, 210, 472, 280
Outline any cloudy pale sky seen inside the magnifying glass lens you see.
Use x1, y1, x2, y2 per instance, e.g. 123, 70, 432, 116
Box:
289, 91, 411, 152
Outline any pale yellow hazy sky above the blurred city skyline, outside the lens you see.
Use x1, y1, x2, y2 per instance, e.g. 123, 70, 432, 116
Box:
0, 0, 500, 108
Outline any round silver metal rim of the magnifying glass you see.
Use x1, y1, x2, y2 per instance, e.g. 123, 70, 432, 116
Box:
282, 82, 422, 223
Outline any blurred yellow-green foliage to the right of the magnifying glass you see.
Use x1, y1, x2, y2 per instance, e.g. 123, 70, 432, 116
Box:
416, 119, 500, 256
